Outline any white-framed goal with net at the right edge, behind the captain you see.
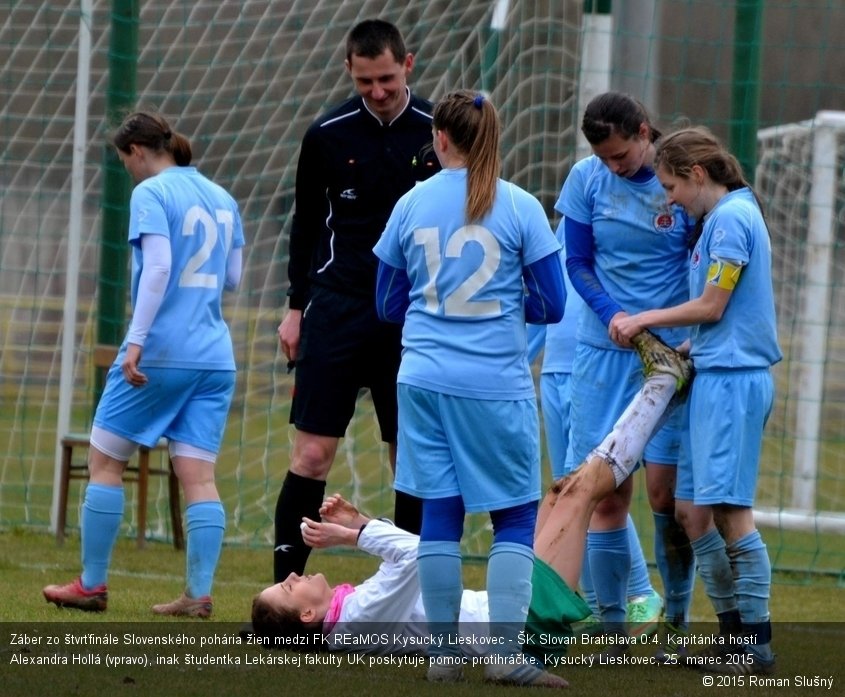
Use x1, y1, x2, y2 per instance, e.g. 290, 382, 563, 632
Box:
756, 111, 845, 540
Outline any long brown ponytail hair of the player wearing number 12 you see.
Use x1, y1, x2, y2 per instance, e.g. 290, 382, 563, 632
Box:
432, 90, 501, 221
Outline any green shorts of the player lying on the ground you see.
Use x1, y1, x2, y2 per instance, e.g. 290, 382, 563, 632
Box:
523, 558, 590, 656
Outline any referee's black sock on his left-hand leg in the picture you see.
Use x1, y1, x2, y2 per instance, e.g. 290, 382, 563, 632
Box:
273, 472, 326, 583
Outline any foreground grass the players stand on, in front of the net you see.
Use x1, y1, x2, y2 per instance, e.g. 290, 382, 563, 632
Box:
0, 530, 845, 697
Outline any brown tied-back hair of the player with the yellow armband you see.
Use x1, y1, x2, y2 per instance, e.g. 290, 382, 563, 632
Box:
654, 126, 763, 245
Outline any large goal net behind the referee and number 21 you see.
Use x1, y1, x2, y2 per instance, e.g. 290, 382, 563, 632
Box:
0, 0, 582, 553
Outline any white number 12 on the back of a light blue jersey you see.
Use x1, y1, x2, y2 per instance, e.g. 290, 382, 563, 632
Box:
414, 225, 502, 317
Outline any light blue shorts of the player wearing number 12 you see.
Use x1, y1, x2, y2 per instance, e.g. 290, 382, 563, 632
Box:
395, 384, 540, 513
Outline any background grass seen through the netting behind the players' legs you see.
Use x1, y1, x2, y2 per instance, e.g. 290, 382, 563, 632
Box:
0, 392, 845, 586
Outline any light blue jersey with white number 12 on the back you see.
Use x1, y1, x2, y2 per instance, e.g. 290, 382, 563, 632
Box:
374, 169, 560, 400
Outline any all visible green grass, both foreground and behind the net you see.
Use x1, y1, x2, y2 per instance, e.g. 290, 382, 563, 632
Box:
0, 368, 845, 697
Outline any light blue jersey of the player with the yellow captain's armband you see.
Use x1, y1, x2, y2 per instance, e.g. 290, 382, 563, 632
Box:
689, 188, 783, 370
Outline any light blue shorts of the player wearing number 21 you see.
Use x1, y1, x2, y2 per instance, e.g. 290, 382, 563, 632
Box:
94, 363, 235, 453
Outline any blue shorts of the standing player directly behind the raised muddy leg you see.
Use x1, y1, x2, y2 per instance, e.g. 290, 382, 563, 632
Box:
569, 343, 681, 465
